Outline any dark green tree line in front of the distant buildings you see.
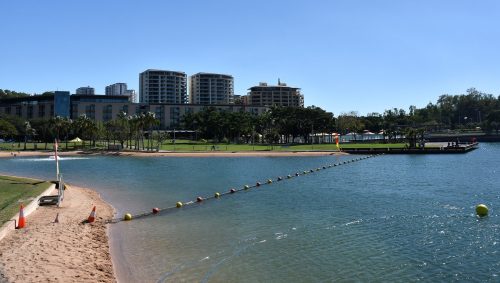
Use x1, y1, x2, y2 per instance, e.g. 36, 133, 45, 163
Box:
0, 88, 500, 149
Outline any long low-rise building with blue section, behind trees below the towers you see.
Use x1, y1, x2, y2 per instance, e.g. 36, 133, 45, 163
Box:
0, 91, 267, 129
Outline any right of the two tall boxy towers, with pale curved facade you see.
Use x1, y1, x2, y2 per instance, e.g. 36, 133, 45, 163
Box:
189, 73, 234, 105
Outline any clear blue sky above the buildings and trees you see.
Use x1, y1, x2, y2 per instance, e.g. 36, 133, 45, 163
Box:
0, 0, 500, 115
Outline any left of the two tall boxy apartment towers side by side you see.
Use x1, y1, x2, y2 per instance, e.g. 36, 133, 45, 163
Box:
139, 69, 188, 104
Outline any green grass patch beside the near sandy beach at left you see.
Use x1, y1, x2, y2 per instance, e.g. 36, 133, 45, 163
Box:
0, 176, 51, 225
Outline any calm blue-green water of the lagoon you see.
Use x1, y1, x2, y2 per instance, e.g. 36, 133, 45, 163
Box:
0, 144, 500, 282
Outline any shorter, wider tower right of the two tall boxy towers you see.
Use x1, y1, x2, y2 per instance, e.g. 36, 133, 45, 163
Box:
243, 80, 304, 107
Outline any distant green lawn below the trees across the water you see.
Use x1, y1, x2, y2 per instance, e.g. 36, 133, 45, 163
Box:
0, 140, 405, 153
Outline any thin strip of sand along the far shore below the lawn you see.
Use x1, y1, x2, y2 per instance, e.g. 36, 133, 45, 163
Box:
0, 151, 348, 158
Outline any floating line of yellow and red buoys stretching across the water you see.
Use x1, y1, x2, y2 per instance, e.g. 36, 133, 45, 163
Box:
106, 153, 383, 223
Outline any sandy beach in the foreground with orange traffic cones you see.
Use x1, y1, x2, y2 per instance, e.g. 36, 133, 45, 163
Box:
0, 185, 116, 282
